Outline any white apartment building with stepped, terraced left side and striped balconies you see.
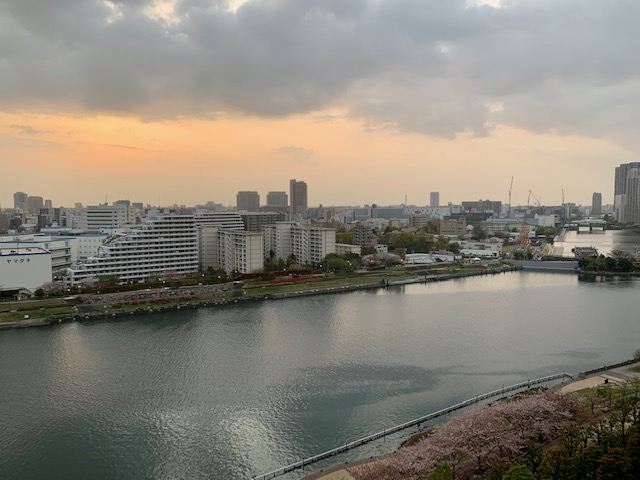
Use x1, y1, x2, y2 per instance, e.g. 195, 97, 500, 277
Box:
66, 213, 198, 285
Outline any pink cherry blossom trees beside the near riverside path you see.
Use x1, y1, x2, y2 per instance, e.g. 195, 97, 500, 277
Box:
349, 393, 581, 480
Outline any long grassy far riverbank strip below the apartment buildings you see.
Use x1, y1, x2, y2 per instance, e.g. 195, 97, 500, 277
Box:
0, 265, 521, 330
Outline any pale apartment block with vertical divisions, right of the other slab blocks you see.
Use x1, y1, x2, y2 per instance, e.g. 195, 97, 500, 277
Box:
264, 222, 336, 265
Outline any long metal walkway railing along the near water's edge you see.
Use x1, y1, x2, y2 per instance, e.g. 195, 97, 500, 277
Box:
251, 372, 574, 480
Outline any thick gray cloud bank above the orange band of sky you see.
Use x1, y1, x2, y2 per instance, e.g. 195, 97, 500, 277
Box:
0, 0, 640, 141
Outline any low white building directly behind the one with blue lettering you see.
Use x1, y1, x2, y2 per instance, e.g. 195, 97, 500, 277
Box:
0, 233, 78, 276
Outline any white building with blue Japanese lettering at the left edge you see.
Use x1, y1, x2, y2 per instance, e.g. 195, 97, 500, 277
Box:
0, 246, 52, 294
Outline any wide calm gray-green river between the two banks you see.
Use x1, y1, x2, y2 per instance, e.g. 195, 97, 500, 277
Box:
0, 233, 640, 480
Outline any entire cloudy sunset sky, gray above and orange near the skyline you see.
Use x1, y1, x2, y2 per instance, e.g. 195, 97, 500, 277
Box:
0, 0, 640, 208
